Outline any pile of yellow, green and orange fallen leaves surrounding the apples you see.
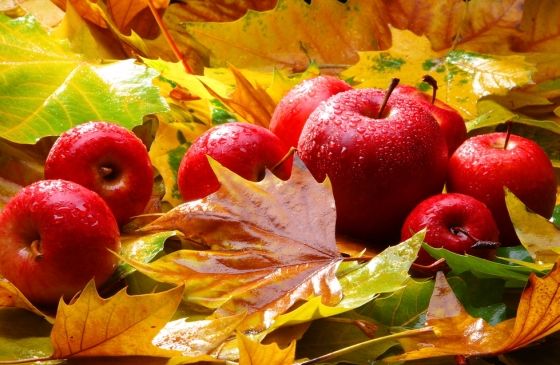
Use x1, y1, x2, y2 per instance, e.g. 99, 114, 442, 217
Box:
0, 0, 560, 364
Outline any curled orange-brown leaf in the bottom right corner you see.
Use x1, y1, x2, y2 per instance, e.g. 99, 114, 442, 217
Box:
388, 260, 560, 361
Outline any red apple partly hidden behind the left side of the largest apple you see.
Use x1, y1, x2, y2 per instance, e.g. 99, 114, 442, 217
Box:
269, 76, 352, 147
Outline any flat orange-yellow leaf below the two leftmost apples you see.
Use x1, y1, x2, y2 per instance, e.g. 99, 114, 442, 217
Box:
51, 282, 183, 359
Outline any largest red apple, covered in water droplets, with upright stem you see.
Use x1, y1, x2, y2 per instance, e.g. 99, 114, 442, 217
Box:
298, 89, 447, 244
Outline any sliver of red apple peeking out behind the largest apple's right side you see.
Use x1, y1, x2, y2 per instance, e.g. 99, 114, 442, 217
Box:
394, 85, 467, 156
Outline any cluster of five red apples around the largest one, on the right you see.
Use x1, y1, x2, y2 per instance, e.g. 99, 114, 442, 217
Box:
270, 76, 556, 265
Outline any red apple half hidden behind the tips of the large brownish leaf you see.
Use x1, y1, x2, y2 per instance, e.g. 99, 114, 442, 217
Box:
177, 122, 292, 201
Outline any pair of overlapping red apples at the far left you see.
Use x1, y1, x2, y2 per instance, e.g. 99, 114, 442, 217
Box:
0, 122, 153, 306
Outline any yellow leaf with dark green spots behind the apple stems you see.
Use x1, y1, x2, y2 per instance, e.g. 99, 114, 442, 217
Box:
341, 29, 534, 119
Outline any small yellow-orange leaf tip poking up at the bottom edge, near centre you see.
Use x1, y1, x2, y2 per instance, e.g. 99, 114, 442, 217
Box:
237, 332, 296, 365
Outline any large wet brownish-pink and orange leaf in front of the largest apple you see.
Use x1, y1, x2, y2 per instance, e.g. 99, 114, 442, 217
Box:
126, 160, 342, 330
